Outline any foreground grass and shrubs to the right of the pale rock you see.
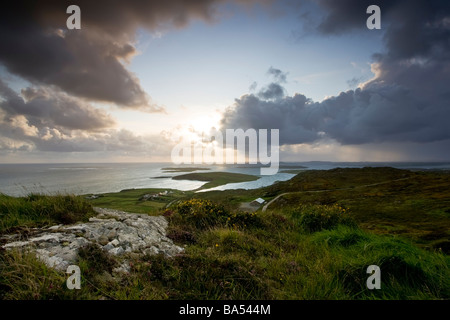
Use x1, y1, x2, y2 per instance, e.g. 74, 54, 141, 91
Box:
152, 205, 450, 299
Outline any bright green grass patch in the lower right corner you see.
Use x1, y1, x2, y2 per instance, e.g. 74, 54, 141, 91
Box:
312, 227, 450, 299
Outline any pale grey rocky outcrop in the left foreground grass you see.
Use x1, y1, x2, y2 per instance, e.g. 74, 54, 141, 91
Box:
2, 208, 183, 271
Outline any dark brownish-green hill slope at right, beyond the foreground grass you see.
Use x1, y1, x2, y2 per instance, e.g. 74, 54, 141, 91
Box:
260, 168, 450, 253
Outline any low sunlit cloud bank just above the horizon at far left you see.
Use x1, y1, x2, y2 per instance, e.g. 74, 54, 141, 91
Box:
0, 80, 178, 155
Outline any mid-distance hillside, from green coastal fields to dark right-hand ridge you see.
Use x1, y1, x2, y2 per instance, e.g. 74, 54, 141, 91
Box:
85, 168, 450, 253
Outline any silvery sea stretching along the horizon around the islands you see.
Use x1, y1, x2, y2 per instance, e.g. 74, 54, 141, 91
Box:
0, 161, 450, 196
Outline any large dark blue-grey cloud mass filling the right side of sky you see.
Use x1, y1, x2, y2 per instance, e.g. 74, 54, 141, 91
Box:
222, 0, 450, 145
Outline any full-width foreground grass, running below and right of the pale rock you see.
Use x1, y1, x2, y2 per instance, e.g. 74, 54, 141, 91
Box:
0, 201, 450, 300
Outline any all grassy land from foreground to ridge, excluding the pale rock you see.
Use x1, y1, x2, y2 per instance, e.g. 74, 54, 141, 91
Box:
0, 168, 450, 300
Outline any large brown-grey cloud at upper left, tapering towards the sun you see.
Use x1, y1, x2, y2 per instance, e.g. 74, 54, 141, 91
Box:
0, 29, 156, 111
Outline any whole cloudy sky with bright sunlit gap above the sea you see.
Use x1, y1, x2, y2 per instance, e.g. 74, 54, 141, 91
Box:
0, 0, 450, 163
